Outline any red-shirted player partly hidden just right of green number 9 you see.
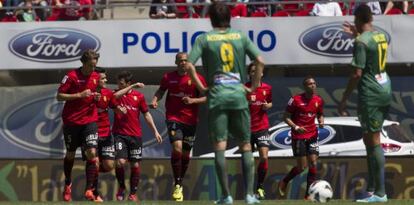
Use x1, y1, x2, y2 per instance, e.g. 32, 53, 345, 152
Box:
245, 63, 273, 199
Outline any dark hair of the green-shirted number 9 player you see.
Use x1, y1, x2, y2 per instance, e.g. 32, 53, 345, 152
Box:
208, 1, 231, 28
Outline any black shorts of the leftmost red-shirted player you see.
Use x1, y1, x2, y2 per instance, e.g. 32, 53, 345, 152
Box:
63, 122, 98, 152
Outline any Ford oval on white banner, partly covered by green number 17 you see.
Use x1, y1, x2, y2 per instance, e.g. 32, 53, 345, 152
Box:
299, 22, 391, 57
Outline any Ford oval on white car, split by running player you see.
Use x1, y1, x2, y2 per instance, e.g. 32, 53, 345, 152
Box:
270, 125, 336, 149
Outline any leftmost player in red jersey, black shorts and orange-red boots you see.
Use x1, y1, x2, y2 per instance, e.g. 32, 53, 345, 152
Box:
56, 50, 99, 201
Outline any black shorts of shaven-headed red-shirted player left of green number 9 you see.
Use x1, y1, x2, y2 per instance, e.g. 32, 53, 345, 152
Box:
166, 121, 196, 150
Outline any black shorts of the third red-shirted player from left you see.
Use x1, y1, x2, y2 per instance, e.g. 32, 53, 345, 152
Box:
115, 134, 142, 162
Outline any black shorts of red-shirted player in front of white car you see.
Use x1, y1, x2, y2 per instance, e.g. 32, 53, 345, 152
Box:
292, 137, 319, 157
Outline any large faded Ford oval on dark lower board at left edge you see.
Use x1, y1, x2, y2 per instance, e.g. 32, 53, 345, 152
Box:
0, 94, 64, 156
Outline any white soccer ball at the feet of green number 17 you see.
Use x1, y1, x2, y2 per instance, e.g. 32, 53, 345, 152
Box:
308, 180, 333, 203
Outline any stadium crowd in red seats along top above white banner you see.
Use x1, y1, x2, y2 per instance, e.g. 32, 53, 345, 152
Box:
0, 0, 414, 22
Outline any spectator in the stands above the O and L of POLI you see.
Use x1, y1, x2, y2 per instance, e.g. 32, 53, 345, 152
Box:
150, 0, 177, 19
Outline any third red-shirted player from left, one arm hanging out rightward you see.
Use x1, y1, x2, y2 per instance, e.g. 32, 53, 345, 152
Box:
112, 71, 162, 201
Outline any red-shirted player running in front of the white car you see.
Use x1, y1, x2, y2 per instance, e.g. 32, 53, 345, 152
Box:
278, 76, 324, 199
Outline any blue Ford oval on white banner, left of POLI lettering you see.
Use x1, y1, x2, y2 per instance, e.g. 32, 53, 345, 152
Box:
9, 28, 101, 63
